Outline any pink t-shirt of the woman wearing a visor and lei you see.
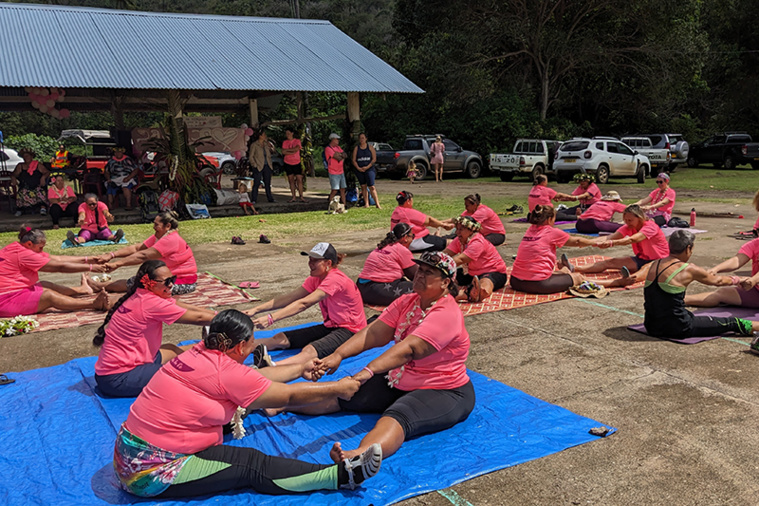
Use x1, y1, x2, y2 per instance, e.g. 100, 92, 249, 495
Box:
379, 293, 469, 392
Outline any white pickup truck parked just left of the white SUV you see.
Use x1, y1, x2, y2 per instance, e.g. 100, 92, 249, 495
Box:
490, 139, 561, 181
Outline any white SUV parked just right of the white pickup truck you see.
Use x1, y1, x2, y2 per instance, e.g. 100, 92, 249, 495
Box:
554, 137, 651, 184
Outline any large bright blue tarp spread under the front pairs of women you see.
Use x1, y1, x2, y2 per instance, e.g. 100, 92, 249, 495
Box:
0, 322, 616, 506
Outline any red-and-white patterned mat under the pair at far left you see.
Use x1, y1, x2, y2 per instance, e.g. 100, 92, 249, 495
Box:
26, 272, 261, 332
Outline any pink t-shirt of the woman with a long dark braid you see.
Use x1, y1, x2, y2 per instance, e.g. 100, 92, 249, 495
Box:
95, 288, 187, 376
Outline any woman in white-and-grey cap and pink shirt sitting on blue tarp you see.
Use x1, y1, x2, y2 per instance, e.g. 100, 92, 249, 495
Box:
246, 242, 366, 367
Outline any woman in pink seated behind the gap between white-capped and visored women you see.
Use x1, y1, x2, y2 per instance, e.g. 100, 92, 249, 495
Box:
356, 223, 416, 306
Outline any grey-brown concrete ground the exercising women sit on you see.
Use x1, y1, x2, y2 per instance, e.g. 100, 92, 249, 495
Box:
0, 175, 759, 506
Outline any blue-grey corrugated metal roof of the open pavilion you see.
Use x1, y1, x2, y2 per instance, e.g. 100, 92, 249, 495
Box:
0, 3, 423, 93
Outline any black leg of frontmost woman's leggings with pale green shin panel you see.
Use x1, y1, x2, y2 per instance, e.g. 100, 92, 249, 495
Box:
157, 445, 347, 497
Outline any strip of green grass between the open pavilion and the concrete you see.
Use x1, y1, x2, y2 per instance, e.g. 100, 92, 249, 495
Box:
0, 193, 527, 256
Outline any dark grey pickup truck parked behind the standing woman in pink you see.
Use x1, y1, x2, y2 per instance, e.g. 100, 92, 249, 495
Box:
388, 134, 482, 179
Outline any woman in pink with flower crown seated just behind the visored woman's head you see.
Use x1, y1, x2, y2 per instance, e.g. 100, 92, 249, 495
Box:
443, 216, 508, 302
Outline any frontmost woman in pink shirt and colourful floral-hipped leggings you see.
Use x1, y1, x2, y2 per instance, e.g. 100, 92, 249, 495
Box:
113, 309, 382, 502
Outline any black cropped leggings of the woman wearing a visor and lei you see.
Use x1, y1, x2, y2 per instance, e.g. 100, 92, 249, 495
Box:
338, 374, 475, 440
